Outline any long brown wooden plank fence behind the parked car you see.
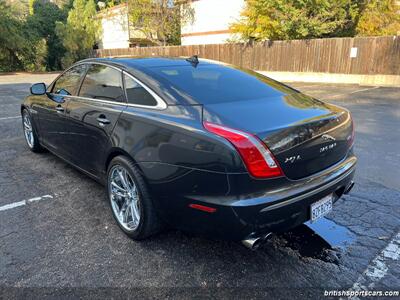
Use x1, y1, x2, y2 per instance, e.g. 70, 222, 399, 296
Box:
94, 36, 400, 75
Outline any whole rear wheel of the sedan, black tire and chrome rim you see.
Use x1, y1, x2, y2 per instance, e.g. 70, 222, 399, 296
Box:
107, 156, 161, 240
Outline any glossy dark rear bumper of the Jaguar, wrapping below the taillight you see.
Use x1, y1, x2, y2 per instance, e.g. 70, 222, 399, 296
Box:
156, 156, 357, 240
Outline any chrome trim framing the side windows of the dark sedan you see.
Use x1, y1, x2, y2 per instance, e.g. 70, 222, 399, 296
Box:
51, 61, 167, 110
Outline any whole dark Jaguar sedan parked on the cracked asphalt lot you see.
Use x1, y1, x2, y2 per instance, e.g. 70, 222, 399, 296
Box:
21, 56, 357, 248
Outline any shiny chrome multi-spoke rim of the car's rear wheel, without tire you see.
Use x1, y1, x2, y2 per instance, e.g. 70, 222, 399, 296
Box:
108, 165, 140, 231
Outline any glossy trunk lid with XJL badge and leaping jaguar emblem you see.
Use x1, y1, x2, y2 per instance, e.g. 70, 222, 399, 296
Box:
203, 92, 352, 179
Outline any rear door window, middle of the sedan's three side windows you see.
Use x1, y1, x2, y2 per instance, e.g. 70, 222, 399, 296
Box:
79, 65, 125, 102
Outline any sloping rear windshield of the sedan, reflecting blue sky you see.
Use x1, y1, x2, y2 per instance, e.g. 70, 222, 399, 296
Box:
152, 62, 287, 104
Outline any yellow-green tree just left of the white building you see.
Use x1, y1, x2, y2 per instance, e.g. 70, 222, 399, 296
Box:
56, 0, 101, 66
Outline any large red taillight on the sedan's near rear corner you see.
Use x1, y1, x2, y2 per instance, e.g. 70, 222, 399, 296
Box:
203, 122, 283, 178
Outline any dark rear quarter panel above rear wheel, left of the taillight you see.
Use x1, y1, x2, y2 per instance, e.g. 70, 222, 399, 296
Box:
112, 106, 246, 173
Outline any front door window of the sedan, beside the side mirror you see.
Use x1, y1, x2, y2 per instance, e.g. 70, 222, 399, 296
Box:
53, 65, 85, 95
